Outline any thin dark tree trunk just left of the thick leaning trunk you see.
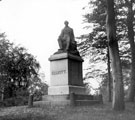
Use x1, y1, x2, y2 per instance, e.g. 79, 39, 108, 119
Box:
107, 47, 112, 102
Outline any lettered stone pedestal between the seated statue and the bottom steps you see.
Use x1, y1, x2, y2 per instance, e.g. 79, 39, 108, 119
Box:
48, 53, 85, 95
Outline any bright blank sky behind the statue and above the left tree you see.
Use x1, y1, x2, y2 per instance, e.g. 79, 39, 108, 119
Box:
0, 0, 89, 83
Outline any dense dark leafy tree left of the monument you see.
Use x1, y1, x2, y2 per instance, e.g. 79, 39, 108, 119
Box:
0, 34, 40, 98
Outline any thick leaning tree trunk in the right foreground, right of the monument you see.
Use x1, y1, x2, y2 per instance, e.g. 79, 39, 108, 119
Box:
106, 0, 125, 110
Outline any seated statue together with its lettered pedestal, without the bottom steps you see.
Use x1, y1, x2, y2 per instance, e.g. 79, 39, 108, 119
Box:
48, 21, 85, 95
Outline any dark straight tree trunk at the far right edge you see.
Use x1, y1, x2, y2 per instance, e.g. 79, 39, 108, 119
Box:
127, 0, 135, 102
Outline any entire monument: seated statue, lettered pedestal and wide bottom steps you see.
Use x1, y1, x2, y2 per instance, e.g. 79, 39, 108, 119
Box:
43, 21, 103, 105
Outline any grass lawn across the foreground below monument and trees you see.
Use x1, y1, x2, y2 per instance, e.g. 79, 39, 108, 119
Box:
0, 102, 135, 120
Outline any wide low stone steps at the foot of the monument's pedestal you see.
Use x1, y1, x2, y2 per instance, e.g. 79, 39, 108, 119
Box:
42, 94, 102, 106
